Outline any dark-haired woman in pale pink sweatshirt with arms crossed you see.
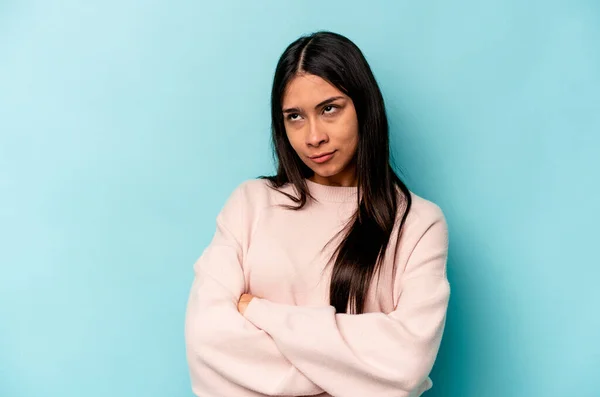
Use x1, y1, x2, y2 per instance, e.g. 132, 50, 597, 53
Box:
186, 32, 450, 397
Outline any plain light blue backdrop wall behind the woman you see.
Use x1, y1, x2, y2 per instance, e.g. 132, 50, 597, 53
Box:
0, 0, 600, 397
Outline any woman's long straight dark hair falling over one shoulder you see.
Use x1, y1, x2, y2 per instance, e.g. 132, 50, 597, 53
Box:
263, 31, 411, 314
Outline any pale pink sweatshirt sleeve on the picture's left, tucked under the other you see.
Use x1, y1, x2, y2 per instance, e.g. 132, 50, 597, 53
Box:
185, 181, 323, 396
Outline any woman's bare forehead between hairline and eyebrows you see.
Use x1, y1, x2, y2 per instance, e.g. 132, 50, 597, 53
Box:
282, 74, 345, 108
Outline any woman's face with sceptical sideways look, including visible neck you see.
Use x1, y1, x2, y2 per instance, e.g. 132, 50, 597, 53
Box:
282, 74, 358, 186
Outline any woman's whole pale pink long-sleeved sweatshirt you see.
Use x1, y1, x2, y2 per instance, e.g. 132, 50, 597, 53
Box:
185, 180, 450, 397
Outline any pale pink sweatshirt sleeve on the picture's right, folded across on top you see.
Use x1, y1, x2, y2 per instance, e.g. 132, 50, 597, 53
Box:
245, 210, 450, 397
